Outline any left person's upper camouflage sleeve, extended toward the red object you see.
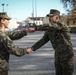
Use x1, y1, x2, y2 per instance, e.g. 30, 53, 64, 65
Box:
5, 30, 27, 40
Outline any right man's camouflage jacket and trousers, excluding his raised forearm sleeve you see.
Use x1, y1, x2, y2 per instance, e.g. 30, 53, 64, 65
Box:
32, 23, 74, 75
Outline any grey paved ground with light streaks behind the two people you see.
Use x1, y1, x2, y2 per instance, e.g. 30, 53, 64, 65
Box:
9, 31, 76, 75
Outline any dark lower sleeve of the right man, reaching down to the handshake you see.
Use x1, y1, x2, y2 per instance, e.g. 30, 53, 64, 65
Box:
31, 32, 49, 51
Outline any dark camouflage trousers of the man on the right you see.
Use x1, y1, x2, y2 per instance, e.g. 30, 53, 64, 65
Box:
55, 57, 74, 75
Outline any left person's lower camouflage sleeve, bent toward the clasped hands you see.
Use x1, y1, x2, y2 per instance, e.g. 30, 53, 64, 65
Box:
2, 37, 26, 56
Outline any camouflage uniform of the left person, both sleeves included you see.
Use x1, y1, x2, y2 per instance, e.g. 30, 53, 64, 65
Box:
0, 31, 27, 75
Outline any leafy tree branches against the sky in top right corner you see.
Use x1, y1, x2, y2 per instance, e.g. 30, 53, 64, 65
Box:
60, 0, 76, 17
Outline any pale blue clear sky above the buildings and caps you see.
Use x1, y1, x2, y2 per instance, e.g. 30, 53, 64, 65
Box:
0, 0, 66, 22
